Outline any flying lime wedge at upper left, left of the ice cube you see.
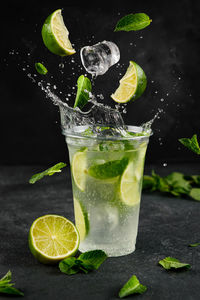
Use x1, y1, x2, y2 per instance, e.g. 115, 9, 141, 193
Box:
42, 9, 76, 56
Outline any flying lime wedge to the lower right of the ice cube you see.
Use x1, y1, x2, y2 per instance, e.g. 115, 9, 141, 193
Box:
111, 61, 147, 103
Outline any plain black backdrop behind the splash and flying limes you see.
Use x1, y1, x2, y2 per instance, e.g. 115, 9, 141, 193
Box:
0, 0, 200, 165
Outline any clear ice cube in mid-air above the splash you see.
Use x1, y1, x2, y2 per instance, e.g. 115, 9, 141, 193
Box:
80, 41, 120, 76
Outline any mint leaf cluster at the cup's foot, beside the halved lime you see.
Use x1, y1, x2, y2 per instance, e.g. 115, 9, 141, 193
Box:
59, 250, 107, 275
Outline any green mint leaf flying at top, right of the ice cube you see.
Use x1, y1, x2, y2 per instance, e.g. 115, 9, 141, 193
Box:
114, 13, 152, 31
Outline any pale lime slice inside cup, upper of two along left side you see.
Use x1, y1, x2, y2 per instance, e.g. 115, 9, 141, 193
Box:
72, 149, 87, 192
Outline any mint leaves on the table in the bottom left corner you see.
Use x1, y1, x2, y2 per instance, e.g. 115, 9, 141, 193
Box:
0, 271, 24, 296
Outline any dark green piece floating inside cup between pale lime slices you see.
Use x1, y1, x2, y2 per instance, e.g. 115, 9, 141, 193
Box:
88, 157, 128, 179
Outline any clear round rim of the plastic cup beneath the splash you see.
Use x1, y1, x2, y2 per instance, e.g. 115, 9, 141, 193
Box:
62, 124, 153, 141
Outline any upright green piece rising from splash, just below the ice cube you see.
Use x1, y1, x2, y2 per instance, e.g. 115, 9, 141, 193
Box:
74, 75, 92, 109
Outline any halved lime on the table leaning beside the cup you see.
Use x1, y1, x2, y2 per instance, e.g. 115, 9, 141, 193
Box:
29, 215, 80, 264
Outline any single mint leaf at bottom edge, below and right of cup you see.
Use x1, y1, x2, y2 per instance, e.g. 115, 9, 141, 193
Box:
119, 275, 147, 298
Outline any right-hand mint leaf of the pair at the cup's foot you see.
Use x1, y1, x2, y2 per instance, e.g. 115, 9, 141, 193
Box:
78, 250, 107, 270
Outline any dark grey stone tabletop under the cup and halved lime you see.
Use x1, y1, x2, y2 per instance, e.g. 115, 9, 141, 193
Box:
0, 164, 200, 300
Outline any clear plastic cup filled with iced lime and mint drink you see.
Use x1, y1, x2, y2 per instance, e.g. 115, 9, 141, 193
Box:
64, 126, 150, 256
